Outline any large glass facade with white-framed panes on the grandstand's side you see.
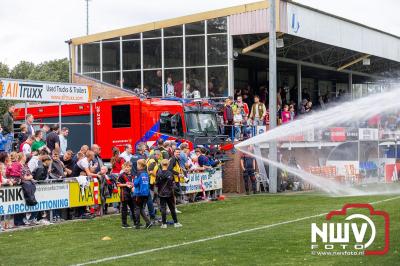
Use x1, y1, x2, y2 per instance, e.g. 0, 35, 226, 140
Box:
76, 17, 229, 97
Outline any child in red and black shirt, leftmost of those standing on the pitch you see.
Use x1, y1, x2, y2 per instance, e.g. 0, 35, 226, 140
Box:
118, 162, 136, 228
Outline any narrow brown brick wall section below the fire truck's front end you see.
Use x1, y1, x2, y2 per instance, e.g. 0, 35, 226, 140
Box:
222, 151, 244, 193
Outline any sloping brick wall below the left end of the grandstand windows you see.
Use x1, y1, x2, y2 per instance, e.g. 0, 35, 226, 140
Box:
72, 74, 133, 99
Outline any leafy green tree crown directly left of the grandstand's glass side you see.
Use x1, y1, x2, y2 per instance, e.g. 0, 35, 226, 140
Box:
28, 58, 69, 82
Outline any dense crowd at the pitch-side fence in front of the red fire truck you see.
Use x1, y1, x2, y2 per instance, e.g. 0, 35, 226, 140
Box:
0, 106, 220, 231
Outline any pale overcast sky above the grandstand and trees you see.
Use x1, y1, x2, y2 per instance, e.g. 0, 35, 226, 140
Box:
0, 0, 400, 66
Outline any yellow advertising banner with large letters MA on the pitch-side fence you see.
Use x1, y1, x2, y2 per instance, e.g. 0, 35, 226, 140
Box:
69, 182, 120, 208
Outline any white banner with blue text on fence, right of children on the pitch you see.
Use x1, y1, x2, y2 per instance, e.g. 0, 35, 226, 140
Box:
181, 170, 222, 194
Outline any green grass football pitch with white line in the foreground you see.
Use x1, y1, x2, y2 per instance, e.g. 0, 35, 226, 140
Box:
0, 193, 400, 265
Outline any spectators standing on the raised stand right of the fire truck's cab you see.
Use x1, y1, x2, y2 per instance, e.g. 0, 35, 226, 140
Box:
221, 86, 354, 141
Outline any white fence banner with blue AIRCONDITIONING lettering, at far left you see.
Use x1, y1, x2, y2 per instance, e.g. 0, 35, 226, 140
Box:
0, 183, 69, 215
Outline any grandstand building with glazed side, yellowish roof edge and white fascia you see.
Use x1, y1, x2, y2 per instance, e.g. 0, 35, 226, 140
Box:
69, 1, 400, 103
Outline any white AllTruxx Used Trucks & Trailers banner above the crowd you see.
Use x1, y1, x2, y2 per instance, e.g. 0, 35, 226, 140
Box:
0, 79, 92, 103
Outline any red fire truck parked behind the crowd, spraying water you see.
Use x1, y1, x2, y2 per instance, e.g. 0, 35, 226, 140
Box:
15, 97, 226, 159
